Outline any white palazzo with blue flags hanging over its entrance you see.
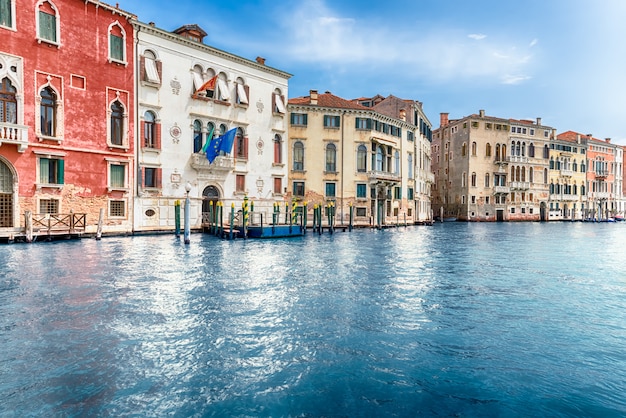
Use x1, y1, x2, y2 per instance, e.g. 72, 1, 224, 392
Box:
134, 22, 291, 231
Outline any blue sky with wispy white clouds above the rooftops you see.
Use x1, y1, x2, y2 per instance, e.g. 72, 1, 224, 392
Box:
118, 0, 626, 145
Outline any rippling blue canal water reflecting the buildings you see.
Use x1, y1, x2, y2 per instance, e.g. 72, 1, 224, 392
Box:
0, 223, 626, 417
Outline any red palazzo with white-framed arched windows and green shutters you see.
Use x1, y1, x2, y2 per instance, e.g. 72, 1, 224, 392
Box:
0, 0, 135, 236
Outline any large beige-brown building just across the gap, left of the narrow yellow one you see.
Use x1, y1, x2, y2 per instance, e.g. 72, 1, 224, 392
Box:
432, 110, 553, 221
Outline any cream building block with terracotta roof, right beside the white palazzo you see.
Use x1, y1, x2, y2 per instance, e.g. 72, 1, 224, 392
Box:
286, 90, 433, 226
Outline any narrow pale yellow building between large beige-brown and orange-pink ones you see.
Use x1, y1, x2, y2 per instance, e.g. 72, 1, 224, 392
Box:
549, 131, 588, 220
